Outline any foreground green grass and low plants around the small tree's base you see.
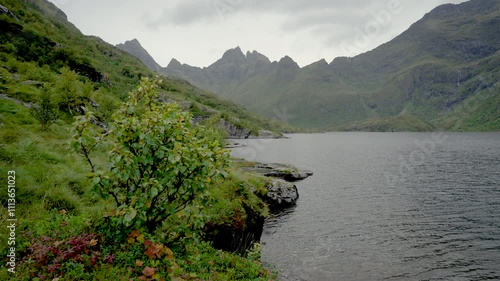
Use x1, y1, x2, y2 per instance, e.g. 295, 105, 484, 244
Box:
0, 97, 275, 280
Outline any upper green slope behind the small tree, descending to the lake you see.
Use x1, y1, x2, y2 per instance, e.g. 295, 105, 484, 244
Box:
0, 0, 291, 137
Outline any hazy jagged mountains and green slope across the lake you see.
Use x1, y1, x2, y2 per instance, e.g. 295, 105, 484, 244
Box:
162, 0, 500, 131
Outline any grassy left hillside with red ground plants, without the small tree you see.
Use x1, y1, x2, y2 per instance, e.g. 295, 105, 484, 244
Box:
0, 0, 283, 280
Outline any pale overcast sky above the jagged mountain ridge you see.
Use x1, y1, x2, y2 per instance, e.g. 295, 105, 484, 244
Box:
50, 0, 465, 67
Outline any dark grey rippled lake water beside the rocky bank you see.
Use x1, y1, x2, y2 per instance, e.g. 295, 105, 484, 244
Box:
232, 133, 500, 281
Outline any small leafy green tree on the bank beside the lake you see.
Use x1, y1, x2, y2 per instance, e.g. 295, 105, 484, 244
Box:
75, 78, 228, 232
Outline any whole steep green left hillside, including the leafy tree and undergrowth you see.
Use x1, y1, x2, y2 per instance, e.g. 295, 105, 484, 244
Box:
0, 0, 282, 280
